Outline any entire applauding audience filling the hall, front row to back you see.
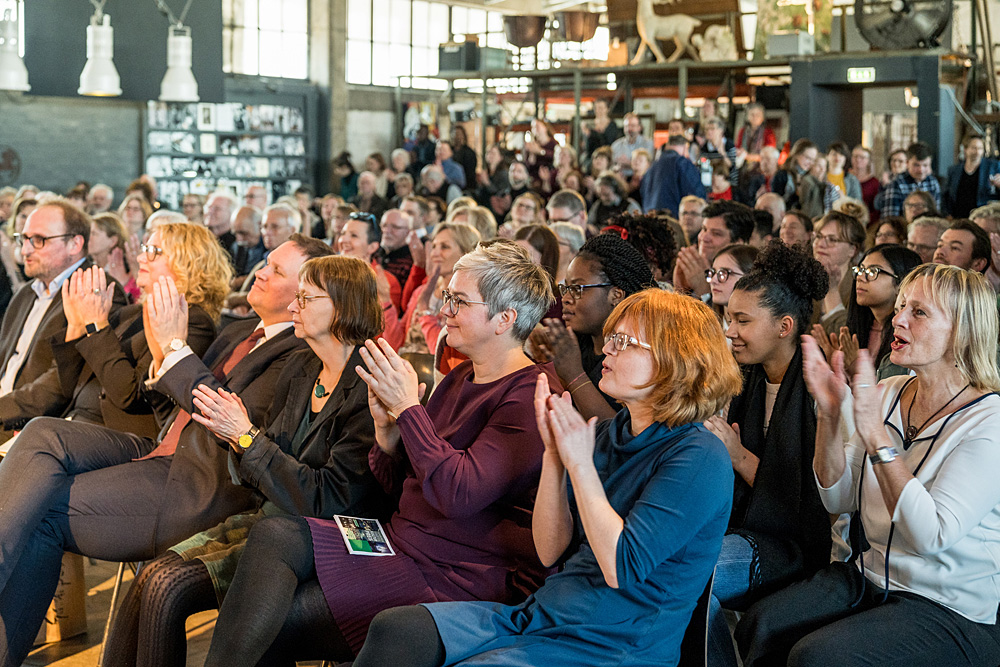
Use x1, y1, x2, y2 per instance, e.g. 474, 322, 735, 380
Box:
0, 102, 1000, 667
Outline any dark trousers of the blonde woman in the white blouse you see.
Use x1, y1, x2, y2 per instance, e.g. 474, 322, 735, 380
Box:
736, 563, 1000, 667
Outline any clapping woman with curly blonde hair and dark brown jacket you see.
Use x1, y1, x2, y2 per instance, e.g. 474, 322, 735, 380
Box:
52, 223, 232, 438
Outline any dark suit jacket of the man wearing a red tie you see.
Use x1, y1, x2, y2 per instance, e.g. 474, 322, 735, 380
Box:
150, 320, 305, 553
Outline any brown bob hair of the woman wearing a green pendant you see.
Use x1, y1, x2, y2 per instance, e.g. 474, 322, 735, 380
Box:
299, 255, 385, 345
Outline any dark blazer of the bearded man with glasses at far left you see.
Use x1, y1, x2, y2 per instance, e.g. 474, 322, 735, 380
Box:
0, 259, 128, 442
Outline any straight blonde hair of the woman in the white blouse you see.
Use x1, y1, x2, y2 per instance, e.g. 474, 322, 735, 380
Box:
896, 264, 1000, 391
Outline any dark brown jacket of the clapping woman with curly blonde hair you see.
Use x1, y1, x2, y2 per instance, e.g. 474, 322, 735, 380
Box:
52, 304, 215, 438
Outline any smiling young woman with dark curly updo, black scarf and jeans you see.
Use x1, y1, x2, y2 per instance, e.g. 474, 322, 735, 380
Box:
705, 241, 844, 665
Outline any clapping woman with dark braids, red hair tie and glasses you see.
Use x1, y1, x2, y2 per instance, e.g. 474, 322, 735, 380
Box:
529, 234, 654, 419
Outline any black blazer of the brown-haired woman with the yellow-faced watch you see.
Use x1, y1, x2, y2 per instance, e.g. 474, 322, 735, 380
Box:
238, 349, 396, 521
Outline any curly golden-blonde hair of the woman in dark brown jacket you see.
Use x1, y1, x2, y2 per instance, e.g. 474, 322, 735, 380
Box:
155, 222, 233, 320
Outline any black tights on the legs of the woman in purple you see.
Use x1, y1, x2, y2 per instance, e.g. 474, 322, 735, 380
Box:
205, 517, 354, 667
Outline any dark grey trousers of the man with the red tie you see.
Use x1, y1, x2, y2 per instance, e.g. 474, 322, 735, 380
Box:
0, 418, 170, 667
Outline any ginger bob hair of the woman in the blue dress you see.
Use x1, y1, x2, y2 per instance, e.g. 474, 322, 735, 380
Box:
604, 288, 743, 428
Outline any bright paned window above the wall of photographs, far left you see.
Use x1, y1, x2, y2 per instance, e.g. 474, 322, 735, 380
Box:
222, 0, 309, 79
